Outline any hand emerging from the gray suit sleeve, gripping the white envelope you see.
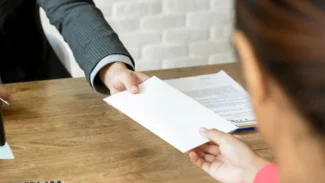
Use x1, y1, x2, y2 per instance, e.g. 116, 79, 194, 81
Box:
99, 62, 149, 95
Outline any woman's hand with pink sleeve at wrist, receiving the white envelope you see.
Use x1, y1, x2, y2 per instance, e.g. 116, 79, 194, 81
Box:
188, 129, 268, 183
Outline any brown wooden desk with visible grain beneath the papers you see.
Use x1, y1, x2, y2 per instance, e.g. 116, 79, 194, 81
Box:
0, 64, 272, 183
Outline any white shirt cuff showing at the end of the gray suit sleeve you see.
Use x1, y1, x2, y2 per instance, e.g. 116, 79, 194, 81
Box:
90, 54, 134, 95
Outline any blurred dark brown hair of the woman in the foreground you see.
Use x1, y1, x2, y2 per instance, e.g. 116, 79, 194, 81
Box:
235, 0, 325, 137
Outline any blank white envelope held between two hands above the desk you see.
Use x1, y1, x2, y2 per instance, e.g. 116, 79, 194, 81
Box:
104, 76, 237, 153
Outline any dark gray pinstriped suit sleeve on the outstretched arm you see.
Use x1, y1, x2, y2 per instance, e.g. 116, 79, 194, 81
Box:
37, 0, 134, 82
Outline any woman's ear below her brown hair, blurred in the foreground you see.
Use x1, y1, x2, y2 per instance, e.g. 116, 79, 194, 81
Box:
233, 31, 267, 104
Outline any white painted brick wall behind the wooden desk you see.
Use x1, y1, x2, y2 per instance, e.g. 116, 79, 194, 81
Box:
42, 0, 236, 77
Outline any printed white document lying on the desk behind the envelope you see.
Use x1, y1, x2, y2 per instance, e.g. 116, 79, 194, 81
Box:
165, 71, 255, 125
